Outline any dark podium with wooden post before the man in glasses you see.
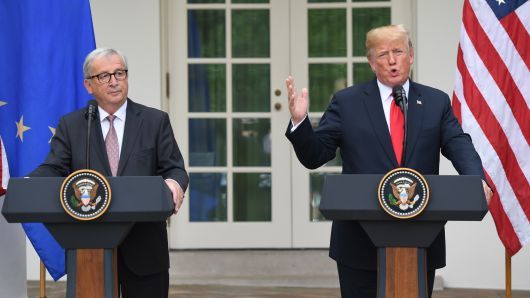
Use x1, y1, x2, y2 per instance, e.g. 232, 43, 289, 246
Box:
2, 176, 174, 298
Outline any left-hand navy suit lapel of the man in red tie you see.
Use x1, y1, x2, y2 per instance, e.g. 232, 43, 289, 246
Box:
363, 80, 398, 167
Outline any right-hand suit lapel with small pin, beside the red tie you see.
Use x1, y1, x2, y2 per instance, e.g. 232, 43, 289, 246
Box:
405, 81, 424, 166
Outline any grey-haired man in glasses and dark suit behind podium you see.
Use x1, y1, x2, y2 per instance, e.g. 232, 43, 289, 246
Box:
30, 49, 188, 297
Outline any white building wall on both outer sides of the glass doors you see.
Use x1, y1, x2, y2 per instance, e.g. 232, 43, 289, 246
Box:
27, 0, 530, 290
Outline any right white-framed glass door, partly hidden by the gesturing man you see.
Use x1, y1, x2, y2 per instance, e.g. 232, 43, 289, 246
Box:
290, 0, 412, 247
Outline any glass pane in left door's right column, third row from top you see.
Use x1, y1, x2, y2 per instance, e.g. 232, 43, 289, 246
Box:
232, 118, 271, 167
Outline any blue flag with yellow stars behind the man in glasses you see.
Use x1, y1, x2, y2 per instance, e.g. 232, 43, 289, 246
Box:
0, 0, 95, 280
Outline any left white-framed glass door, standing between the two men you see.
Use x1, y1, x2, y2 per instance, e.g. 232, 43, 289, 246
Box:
167, 0, 292, 248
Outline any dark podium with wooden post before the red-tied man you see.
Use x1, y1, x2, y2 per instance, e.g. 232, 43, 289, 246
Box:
320, 174, 488, 298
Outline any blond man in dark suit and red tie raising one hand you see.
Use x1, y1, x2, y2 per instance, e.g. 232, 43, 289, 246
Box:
286, 25, 492, 298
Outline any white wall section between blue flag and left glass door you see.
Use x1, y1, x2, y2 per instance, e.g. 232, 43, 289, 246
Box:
90, 0, 161, 108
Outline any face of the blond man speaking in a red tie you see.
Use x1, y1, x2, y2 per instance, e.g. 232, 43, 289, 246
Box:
368, 40, 414, 88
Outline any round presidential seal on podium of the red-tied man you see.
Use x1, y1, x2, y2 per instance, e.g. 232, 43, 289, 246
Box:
378, 168, 429, 219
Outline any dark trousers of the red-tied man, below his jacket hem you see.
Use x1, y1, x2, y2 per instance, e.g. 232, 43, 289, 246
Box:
337, 263, 436, 298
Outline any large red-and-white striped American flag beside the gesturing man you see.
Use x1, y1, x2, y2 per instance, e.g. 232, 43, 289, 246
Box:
453, 0, 530, 255
